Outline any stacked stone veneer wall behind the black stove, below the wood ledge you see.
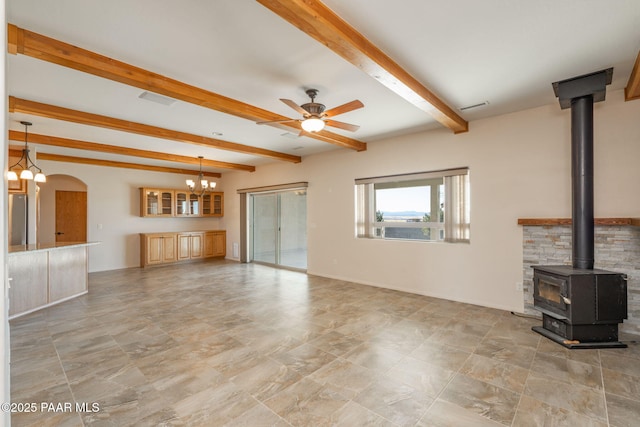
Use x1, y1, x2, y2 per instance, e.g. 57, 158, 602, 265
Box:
522, 225, 640, 335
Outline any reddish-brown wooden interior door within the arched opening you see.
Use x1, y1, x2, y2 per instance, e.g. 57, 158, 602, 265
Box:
56, 190, 87, 242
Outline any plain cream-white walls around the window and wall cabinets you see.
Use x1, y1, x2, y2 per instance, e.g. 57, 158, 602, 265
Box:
36, 91, 640, 311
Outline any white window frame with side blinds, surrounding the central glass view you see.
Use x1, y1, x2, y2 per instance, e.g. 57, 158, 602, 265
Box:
355, 168, 471, 243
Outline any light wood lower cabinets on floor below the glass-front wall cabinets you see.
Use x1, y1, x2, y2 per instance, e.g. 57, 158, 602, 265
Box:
140, 230, 226, 267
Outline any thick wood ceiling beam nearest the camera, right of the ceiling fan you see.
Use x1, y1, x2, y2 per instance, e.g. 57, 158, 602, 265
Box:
257, 0, 469, 133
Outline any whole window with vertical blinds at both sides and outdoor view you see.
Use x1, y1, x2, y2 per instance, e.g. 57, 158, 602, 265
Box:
355, 168, 470, 242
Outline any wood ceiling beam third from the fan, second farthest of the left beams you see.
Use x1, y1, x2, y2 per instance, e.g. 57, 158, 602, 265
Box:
9, 130, 230, 178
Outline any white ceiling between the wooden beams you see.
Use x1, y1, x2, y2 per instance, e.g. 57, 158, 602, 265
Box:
6, 0, 640, 173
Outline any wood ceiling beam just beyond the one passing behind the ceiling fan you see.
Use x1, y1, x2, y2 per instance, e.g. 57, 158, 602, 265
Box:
9, 96, 286, 170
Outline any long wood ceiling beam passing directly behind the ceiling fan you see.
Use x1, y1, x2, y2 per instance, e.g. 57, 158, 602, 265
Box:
7, 24, 367, 152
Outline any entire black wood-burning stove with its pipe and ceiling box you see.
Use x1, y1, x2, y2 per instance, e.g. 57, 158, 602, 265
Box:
532, 68, 627, 348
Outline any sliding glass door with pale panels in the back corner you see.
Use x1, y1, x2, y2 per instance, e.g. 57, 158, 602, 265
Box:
250, 189, 307, 269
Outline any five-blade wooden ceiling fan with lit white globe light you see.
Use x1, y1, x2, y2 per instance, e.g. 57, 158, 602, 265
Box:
258, 89, 364, 132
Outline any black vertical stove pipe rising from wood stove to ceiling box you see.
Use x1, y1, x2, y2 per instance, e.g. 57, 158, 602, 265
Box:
571, 95, 595, 270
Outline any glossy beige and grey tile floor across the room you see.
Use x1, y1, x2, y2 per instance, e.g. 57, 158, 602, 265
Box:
11, 261, 640, 427
